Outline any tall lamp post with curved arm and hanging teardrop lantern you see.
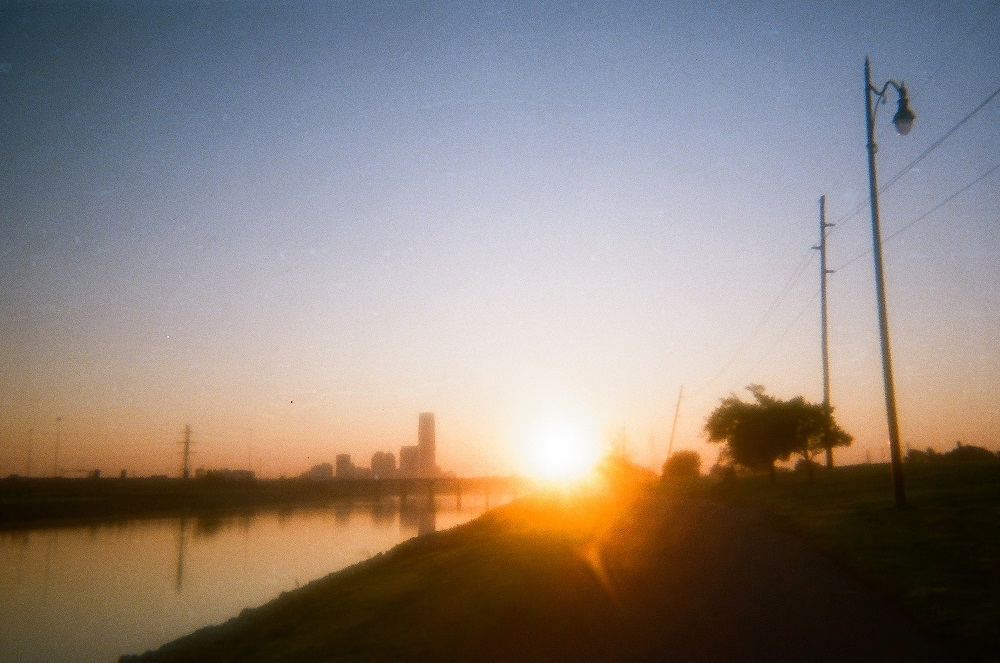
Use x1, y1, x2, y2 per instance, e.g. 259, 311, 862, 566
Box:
865, 58, 916, 507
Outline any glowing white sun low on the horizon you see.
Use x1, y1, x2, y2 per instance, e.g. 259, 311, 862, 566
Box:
524, 421, 600, 483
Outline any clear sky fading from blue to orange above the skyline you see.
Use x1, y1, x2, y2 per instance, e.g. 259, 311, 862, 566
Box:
0, 0, 1000, 476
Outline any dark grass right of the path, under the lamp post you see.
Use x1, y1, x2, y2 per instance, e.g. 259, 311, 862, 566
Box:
679, 463, 1000, 660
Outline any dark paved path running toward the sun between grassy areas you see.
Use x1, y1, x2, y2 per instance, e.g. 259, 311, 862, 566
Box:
584, 497, 954, 662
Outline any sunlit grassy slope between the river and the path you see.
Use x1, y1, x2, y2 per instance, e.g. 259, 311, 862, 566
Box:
123, 482, 640, 661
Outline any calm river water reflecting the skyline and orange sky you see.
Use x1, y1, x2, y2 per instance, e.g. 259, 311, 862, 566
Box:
0, 494, 500, 663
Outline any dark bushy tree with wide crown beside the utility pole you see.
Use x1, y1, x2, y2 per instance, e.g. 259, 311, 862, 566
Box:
705, 385, 853, 483
